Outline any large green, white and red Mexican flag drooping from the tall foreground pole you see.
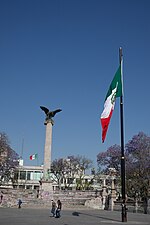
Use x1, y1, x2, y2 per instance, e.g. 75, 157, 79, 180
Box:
101, 65, 122, 142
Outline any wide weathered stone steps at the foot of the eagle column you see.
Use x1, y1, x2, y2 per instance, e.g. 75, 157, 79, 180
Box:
1, 189, 94, 208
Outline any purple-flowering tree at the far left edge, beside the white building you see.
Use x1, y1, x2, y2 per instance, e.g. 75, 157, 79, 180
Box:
0, 133, 18, 185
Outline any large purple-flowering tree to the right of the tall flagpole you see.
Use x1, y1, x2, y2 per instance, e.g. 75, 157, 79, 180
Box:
126, 132, 150, 197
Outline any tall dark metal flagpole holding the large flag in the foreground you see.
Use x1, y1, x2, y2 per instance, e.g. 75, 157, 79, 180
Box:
119, 47, 127, 222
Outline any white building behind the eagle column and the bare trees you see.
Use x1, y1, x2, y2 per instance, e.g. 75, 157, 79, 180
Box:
13, 160, 117, 191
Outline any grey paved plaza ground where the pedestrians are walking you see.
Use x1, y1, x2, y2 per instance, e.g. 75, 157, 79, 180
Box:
0, 207, 150, 225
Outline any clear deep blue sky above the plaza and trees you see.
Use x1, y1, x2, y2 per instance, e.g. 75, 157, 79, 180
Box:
0, 0, 150, 169
